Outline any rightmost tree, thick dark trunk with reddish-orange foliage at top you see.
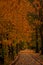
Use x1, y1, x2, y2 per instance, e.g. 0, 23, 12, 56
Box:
28, 0, 43, 54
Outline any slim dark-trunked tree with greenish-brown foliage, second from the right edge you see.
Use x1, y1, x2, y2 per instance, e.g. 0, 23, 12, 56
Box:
27, 12, 39, 53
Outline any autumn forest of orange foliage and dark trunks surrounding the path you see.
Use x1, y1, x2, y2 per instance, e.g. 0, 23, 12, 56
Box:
0, 0, 43, 65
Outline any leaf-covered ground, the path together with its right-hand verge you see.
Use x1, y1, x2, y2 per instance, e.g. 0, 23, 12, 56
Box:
12, 49, 43, 65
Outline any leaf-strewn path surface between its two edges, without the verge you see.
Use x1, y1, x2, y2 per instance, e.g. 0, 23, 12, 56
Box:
13, 50, 43, 65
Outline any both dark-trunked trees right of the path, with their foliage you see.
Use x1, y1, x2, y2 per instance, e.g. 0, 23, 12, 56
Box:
27, 0, 43, 54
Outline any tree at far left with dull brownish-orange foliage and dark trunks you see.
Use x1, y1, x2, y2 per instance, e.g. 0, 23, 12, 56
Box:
0, 17, 15, 64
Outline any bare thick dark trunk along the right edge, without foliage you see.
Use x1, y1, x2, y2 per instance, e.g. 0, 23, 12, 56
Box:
39, 0, 43, 55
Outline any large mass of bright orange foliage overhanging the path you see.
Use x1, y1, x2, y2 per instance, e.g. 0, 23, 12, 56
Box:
0, 0, 39, 41
